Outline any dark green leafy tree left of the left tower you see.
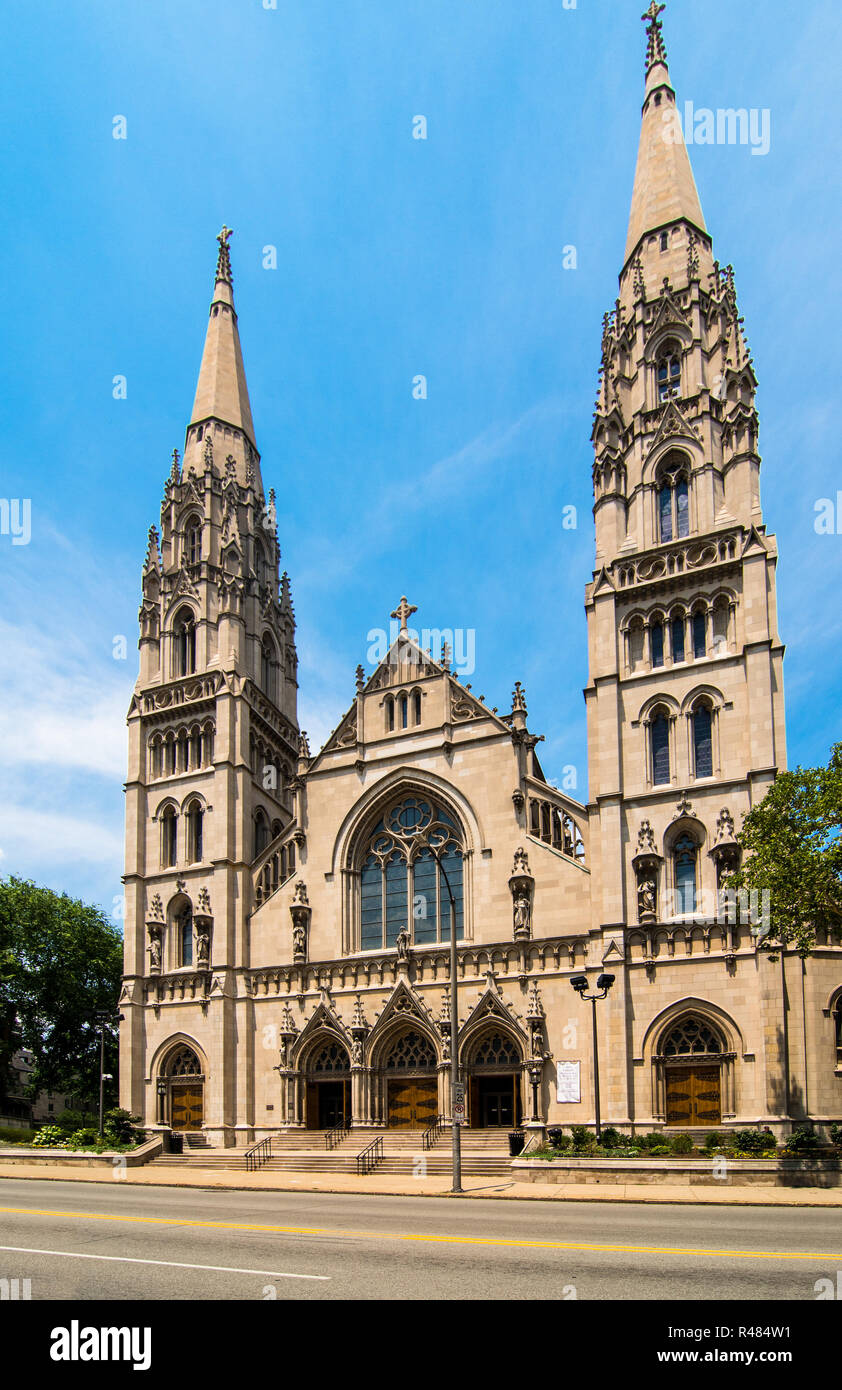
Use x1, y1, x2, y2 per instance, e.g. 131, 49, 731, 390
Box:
0, 877, 122, 1109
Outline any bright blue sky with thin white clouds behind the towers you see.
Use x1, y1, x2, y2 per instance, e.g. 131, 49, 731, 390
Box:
0, 0, 842, 910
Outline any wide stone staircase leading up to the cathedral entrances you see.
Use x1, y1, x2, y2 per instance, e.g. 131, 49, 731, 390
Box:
150, 1127, 511, 1177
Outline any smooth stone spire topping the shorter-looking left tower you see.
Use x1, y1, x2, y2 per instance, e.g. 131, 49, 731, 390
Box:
188, 227, 256, 449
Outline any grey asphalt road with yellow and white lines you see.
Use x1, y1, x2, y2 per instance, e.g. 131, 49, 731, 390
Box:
0, 1179, 842, 1302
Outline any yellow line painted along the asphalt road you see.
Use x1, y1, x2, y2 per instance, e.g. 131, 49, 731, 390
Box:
0, 1207, 842, 1261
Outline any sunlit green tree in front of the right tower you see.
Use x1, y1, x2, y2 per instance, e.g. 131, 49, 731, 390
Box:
727, 744, 842, 956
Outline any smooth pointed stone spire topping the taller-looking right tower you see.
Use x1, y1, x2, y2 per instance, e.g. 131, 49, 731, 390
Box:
624, 0, 707, 263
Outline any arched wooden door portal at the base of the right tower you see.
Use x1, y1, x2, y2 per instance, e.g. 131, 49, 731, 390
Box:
660, 1015, 723, 1127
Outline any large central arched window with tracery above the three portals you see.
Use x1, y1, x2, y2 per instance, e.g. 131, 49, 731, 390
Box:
360, 796, 464, 951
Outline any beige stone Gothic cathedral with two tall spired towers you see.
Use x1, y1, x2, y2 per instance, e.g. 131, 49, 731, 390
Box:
121, 4, 842, 1148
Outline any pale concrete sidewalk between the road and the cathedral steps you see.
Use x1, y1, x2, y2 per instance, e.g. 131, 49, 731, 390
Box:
0, 1163, 842, 1208
